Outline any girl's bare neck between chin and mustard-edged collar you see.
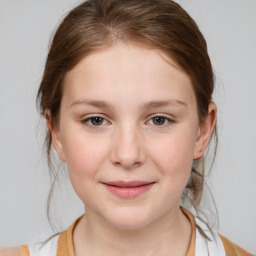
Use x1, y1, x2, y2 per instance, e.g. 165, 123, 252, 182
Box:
73, 208, 191, 256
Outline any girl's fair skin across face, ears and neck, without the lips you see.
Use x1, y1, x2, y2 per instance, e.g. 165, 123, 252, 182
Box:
45, 42, 216, 256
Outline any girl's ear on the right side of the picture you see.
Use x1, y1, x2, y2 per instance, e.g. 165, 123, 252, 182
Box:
194, 103, 217, 159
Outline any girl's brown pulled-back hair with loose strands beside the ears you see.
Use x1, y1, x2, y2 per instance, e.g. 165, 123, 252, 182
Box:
37, 0, 217, 238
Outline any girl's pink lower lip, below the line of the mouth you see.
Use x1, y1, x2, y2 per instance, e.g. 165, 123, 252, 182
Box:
104, 183, 154, 198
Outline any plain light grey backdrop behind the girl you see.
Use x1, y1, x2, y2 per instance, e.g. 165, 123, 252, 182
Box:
0, 0, 256, 253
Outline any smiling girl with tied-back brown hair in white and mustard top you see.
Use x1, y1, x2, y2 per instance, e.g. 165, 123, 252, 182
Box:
0, 0, 254, 256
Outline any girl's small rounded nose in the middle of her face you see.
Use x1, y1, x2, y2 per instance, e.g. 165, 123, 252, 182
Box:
110, 124, 146, 170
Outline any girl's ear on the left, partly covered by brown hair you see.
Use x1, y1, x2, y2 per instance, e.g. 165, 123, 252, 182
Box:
44, 109, 66, 162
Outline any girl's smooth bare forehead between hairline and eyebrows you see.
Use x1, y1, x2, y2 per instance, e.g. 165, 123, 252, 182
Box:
64, 42, 195, 108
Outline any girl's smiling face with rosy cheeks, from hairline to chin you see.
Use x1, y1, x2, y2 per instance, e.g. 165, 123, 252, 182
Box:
52, 43, 214, 228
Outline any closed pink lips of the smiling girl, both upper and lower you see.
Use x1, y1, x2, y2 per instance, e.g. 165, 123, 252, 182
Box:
103, 181, 155, 198
